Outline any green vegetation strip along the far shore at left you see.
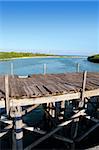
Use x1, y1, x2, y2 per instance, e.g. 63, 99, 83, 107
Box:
0, 52, 54, 60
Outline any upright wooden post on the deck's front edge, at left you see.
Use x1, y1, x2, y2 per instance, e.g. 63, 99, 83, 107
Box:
5, 75, 10, 116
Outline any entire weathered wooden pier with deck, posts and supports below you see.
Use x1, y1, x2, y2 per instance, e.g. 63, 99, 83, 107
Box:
0, 71, 99, 150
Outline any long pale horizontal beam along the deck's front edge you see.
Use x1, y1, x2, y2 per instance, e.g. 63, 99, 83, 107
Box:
0, 89, 99, 108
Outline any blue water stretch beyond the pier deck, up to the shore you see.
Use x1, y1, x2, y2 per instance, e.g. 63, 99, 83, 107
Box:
0, 57, 99, 75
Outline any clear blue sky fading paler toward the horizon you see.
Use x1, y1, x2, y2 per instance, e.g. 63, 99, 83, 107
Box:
0, 0, 99, 55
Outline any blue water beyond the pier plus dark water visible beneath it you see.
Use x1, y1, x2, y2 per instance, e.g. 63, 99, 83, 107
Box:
0, 57, 99, 149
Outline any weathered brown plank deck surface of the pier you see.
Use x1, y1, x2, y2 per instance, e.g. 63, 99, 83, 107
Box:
0, 73, 99, 99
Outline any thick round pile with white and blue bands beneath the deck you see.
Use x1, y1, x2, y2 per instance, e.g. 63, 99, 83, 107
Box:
12, 107, 23, 150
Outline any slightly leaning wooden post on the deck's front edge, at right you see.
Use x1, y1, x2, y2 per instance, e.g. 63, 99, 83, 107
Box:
79, 71, 87, 108
